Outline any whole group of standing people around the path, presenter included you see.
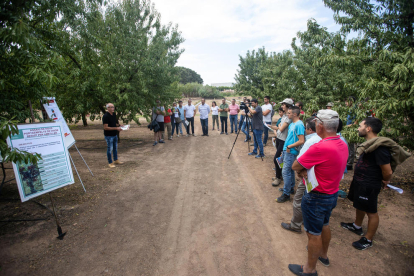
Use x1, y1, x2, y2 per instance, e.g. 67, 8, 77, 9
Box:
103, 97, 410, 276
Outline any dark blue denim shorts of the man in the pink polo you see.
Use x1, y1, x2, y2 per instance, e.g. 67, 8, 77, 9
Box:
301, 192, 338, 236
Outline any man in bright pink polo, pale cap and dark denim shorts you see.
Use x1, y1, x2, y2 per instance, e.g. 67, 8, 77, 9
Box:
289, 109, 348, 276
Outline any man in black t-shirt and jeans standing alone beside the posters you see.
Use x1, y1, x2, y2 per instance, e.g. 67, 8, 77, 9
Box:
102, 103, 124, 168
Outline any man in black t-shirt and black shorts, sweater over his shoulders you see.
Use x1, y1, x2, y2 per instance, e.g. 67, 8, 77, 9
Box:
341, 118, 392, 250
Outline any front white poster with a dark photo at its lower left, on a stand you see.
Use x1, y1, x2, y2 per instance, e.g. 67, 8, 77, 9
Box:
7, 122, 75, 201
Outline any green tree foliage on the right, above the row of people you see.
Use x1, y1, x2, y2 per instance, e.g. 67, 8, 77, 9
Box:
236, 0, 414, 149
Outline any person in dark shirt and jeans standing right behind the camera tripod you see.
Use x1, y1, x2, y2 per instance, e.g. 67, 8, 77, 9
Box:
247, 99, 265, 158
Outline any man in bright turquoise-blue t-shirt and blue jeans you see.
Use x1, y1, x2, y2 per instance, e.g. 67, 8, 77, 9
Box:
276, 106, 305, 203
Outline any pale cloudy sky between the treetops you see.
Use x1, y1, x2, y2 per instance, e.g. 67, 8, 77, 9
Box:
152, 0, 340, 85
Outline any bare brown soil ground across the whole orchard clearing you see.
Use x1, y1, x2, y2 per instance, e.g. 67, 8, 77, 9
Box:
0, 99, 414, 275
